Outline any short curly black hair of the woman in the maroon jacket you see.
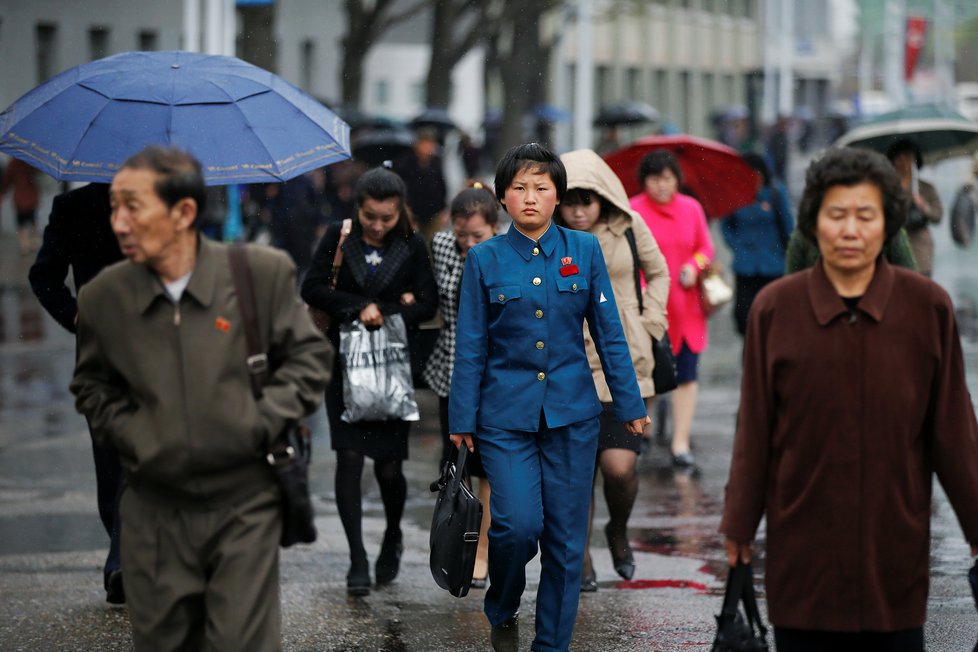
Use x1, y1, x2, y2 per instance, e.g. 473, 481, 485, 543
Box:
798, 147, 910, 244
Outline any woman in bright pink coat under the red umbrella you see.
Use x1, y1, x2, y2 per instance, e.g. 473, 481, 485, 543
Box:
630, 149, 713, 468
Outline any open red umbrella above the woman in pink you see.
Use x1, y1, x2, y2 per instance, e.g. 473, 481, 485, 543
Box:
604, 134, 760, 217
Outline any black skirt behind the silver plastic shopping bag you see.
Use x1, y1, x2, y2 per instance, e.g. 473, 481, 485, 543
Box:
325, 355, 411, 462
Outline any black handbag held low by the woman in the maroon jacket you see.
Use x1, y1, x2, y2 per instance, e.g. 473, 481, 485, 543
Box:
710, 560, 768, 652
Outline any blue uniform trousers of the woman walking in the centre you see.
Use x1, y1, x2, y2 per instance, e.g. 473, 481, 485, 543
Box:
478, 415, 599, 652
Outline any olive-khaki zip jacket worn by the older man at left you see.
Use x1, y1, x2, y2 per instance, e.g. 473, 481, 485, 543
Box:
71, 238, 332, 502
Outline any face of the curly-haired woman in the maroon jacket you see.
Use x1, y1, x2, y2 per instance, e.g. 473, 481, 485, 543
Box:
815, 182, 886, 275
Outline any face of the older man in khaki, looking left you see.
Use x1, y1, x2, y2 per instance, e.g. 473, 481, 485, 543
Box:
109, 168, 192, 269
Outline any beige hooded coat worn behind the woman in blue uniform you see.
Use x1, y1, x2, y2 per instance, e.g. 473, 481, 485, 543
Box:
560, 149, 669, 402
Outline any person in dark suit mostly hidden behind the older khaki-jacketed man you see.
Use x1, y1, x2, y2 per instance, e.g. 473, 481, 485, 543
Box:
28, 183, 126, 604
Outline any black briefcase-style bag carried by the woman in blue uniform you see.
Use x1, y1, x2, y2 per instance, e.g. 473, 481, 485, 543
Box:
429, 445, 482, 598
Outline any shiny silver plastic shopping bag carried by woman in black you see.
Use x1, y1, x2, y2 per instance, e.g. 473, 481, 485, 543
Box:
340, 315, 421, 423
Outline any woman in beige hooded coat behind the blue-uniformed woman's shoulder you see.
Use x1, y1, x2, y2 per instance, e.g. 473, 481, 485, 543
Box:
557, 149, 669, 591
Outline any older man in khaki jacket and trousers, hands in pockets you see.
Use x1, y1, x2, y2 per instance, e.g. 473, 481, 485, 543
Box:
71, 147, 330, 651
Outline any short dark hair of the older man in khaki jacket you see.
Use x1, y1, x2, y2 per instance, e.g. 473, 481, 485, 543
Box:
120, 145, 207, 222
